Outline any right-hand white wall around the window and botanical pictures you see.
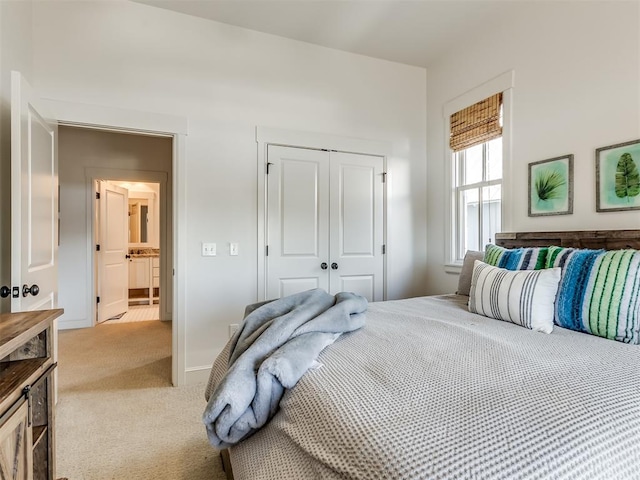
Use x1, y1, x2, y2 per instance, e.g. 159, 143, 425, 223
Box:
427, 2, 640, 294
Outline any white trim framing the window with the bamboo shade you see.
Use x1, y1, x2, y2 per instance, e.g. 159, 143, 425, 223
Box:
442, 70, 515, 273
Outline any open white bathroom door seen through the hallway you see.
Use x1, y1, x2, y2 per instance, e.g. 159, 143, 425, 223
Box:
97, 181, 129, 323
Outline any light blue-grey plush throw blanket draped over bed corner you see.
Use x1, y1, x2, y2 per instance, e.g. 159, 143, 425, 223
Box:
203, 289, 367, 448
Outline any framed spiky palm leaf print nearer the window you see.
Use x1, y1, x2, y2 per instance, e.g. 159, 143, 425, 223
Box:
528, 154, 573, 217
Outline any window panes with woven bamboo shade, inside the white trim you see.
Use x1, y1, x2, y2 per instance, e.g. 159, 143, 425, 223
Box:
450, 93, 503, 262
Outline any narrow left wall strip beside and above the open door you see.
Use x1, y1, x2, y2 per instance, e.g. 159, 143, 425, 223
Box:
0, 1, 33, 312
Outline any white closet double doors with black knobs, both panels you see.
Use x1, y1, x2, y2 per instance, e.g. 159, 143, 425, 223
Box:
266, 145, 384, 301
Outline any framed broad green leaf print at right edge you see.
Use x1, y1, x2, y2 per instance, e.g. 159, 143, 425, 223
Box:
596, 139, 640, 212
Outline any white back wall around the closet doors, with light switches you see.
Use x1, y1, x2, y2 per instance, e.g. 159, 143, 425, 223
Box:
34, 1, 426, 380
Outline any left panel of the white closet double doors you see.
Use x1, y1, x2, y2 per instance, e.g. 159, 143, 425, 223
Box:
266, 145, 329, 298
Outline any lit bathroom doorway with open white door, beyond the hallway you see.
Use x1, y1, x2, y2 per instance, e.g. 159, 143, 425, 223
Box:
94, 182, 161, 324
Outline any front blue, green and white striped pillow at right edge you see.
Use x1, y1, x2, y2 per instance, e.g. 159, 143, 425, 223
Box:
545, 247, 640, 345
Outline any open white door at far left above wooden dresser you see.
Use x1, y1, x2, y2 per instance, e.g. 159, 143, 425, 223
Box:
11, 71, 58, 312
